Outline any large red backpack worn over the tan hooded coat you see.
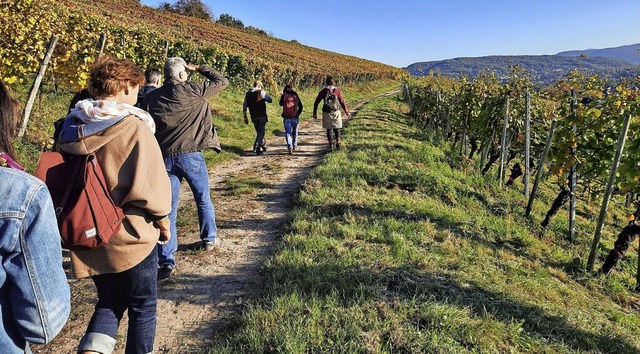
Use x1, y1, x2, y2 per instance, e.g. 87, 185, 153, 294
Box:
35, 152, 124, 250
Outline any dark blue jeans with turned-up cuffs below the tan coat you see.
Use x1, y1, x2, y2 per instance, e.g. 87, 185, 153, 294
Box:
78, 248, 158, 354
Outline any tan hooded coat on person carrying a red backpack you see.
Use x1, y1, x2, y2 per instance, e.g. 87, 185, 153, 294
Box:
60, 116, 171, 278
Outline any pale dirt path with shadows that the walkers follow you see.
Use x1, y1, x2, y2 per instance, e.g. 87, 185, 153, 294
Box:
32, 92, 395, 354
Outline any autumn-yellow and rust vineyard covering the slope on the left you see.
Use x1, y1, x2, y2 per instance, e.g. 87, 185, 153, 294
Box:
0, 0, 405, 89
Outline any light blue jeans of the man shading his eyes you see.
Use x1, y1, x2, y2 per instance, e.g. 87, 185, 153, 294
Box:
158, 151, 218, 267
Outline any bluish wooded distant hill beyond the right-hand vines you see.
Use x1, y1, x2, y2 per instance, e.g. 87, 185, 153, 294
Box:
407, 54, 639, 86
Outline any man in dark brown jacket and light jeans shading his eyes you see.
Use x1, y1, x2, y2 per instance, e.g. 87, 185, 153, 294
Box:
142, 57, 229, 279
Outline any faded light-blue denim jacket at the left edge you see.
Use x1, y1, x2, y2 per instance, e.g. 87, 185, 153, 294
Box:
0, 167, 71, 354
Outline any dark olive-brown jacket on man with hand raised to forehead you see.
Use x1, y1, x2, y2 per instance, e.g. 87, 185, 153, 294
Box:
142, 65, 229, 156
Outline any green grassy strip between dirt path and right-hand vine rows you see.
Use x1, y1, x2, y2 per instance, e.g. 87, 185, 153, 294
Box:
205, 93, 640, 353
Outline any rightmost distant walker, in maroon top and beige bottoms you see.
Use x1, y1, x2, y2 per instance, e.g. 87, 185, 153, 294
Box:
313, 76, 351, 150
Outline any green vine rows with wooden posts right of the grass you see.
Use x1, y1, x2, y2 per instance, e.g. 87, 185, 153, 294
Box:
404, 66, 640, 276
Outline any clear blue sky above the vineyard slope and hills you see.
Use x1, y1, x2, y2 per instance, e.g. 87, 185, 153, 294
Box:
141, 0, 640, 67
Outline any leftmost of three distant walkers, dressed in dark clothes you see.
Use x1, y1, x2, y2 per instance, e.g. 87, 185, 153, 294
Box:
242, 80, 273, 155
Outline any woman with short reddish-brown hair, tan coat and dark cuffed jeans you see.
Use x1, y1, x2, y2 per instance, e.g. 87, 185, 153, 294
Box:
55, 57, 171, 354
